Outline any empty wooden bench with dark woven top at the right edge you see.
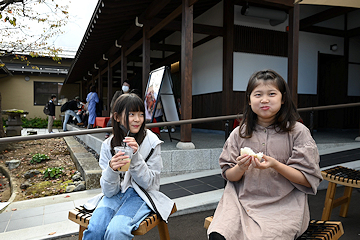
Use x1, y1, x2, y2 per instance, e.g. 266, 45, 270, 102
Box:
321, 166, 360, 221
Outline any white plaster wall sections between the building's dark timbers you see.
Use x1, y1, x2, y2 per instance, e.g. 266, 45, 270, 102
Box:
166, 2, 360, 95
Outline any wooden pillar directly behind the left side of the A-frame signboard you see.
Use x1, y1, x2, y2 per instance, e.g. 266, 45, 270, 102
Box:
141, 24, 150, 96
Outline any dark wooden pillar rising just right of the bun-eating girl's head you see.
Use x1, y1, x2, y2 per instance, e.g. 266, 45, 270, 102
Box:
288, 4, 300, 107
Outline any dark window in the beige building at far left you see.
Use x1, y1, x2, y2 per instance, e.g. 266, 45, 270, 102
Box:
34, 82, 63, 105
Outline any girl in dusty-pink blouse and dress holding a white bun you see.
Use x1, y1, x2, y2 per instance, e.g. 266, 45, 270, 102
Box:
208, 70, 322, 240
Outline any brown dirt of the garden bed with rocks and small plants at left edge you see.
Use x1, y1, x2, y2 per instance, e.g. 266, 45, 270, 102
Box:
0, 138, 76, 202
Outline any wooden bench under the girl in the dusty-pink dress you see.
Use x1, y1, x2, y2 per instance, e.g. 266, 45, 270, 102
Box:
204, 216, 344, 240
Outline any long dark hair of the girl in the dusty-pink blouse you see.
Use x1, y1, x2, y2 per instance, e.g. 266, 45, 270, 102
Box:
239, 69, 300, 138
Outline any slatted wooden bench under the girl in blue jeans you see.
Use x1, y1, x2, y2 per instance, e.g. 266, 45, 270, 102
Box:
68, 204, 177, 240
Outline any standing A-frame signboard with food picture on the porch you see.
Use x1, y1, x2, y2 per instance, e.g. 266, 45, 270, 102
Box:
144, 67, 179, 122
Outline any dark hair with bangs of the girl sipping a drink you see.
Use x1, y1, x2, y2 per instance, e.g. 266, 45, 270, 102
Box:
111, 93, 146, 149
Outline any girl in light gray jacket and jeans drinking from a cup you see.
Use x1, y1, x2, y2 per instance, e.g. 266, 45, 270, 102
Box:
83, 93, 174, 240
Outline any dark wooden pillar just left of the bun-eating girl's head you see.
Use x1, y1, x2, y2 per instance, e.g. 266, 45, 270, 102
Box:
222, 0, 235, 115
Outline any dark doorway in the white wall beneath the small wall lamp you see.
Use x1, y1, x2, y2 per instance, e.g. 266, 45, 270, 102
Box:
317, 53, 348, 129
